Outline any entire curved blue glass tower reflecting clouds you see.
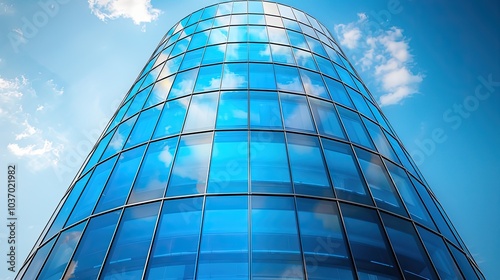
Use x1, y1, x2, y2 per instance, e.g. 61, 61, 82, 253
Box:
18, 1, 484, 280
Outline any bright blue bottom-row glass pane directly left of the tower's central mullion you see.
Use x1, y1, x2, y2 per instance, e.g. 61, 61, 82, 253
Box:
196, 196, 249, 280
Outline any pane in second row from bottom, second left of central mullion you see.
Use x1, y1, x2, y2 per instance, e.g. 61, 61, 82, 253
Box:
167, 133, 213, 196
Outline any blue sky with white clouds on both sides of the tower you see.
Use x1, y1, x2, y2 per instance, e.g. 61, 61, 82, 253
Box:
0, 0, 500, 279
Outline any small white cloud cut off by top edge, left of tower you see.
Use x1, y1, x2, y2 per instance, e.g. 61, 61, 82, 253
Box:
88, 0, 161, 25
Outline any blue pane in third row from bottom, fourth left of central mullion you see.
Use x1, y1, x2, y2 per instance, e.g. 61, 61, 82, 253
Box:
125, 104, 163, 148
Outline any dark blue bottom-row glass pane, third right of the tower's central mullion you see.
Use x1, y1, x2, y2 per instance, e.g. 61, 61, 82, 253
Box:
340, 203, 403, 279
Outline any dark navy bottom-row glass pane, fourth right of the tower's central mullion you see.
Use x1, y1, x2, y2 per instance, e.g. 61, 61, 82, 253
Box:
381, 213, 438, 279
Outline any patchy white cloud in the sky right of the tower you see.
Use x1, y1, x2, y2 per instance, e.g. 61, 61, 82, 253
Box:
335, 14, 424, 106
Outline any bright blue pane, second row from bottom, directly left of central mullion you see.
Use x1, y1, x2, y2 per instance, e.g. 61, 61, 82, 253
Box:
207, 131, 248, 193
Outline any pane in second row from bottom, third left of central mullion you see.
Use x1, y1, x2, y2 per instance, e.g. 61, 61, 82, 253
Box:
128, 137, 178, 203
